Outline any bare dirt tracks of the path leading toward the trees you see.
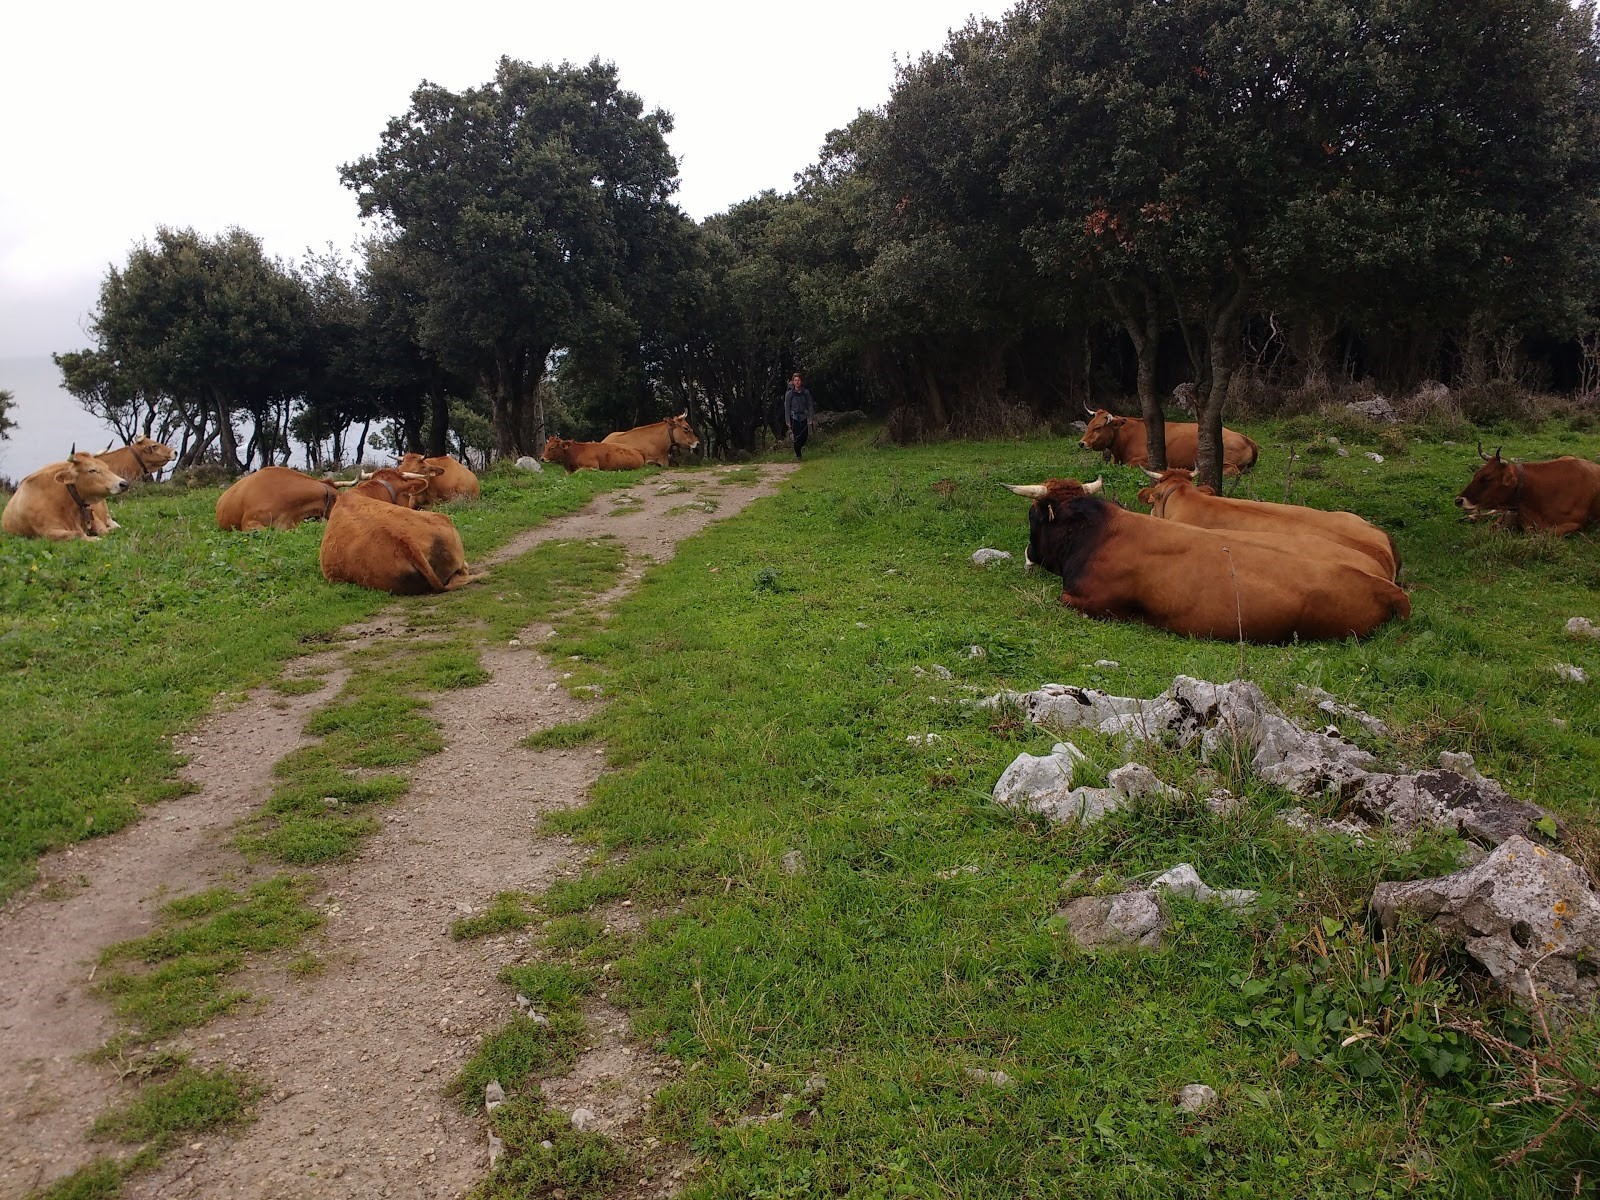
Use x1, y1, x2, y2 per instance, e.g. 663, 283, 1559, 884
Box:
0, 466, 792, 1198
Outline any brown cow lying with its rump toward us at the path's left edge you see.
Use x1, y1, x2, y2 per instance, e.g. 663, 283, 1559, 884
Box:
317, 467, 483, 595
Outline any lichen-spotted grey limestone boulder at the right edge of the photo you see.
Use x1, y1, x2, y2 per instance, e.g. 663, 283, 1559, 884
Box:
1371, 837, 1600, 1006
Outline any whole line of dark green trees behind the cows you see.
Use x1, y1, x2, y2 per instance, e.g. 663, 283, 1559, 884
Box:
58, 0, 1600, 483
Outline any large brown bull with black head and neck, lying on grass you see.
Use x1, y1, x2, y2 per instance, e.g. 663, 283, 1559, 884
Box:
1005, 480, 1411, 642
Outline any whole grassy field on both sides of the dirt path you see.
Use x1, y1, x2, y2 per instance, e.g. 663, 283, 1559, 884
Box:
0, 419, 1600, 1200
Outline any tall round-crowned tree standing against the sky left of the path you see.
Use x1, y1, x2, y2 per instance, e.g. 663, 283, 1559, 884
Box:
341, 58, 677, 456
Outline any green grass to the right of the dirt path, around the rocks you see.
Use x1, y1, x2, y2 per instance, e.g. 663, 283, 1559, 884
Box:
502, 424, 1600, 1198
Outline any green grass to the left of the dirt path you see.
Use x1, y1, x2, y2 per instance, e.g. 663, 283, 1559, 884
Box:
0, 469, 635, 899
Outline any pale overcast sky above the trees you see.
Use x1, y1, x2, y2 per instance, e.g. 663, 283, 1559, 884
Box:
0, 0, 1006, 361
